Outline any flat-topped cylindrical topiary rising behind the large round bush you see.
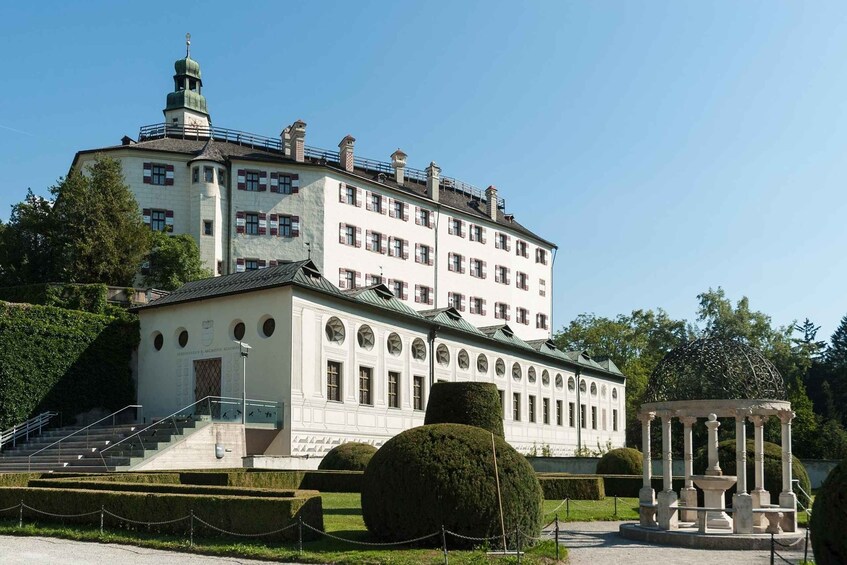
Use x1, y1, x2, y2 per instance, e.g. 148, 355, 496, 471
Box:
424, 383, 505, 437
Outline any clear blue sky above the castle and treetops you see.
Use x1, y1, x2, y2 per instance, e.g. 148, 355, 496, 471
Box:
0, 0, 847, 338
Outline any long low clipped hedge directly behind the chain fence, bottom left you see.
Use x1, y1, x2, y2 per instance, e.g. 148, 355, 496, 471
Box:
0, 487, 323, 540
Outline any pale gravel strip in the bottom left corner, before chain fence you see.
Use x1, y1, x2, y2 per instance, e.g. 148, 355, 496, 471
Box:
0, 536, 294, 565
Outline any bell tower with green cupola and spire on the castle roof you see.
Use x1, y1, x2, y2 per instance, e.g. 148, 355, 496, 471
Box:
163, 33, 212, 132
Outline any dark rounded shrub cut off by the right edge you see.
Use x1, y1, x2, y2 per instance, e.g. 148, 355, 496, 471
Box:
809, 459, 847, 565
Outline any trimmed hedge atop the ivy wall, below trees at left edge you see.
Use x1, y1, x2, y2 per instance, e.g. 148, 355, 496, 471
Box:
0, 283, 109, 314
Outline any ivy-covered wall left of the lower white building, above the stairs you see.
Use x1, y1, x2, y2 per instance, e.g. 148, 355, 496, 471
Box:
0, 302, 139, 429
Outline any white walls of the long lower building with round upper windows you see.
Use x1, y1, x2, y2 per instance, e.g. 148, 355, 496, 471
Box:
138, 264, 626, 456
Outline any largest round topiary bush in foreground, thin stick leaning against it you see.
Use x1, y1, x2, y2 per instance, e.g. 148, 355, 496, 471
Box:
362, 424, 542, 547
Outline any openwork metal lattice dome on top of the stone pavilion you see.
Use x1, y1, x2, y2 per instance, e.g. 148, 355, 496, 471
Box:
647, 337, 785, 402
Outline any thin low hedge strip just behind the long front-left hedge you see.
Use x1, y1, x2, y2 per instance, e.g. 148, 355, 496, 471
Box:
28, 479, 306, 498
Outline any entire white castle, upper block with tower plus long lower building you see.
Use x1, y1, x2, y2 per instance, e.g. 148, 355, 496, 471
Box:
73, 41, 625, 455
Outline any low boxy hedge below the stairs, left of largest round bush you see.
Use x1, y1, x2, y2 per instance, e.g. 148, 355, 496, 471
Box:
179, 470, 363, 493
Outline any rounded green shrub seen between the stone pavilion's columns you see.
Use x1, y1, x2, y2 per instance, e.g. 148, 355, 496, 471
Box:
694, 439, 812, 508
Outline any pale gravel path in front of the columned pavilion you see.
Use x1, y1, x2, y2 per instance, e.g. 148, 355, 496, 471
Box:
559, 522, 812, 565
